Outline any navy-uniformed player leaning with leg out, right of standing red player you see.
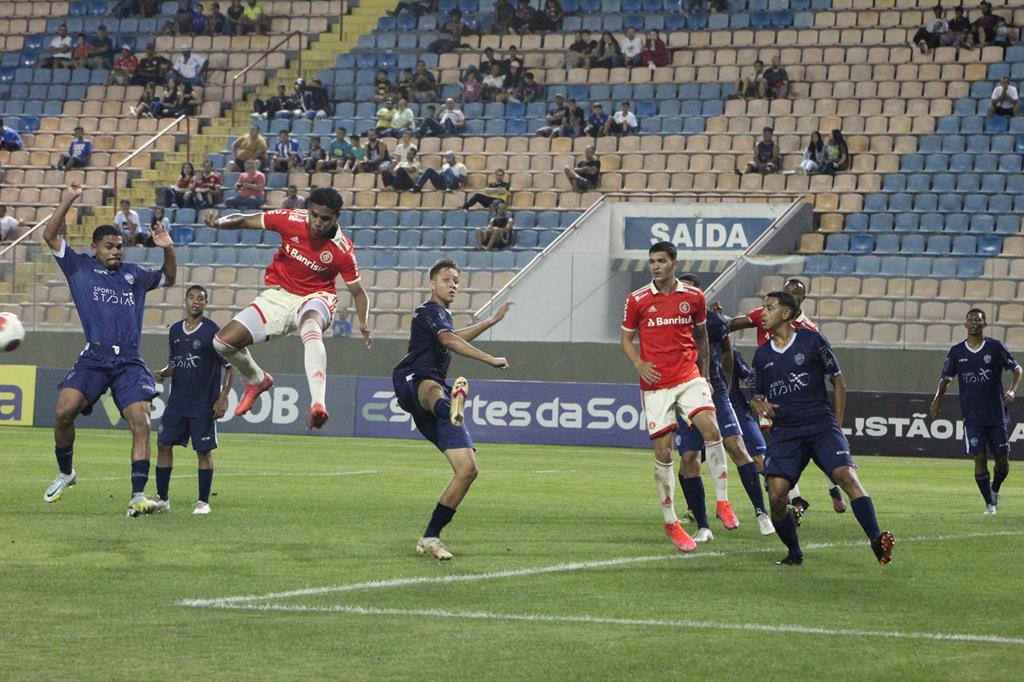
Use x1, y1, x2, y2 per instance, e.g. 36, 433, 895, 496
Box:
751, 291, 896, 565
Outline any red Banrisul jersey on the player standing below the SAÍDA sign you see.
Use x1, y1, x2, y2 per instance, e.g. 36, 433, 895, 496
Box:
623, 280, 708, 391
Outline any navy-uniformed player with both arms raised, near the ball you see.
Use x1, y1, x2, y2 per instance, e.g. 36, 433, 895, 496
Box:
43, 182, 175, 516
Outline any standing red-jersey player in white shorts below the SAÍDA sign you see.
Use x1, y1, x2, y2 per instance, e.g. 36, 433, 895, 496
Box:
622, 242, 725, 552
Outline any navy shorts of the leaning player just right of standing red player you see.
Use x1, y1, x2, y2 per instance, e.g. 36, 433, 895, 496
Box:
765, 422, 856, 485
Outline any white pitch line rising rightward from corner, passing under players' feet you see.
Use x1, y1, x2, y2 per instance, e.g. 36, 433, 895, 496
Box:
175, 530, 1024, 608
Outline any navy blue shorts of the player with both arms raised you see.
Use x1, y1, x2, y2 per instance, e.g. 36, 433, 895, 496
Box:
57, 350, 158, 413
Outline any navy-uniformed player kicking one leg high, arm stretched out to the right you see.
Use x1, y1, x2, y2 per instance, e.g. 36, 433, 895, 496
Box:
391, 259, 510, 560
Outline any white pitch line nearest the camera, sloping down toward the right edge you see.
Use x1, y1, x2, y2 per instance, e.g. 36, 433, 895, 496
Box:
188, 602, 1024, 646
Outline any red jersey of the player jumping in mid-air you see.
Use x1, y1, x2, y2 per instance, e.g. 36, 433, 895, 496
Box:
262, 209, 359, 296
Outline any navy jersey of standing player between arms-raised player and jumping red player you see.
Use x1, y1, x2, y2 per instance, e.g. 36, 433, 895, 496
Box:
167, 317, 227, 417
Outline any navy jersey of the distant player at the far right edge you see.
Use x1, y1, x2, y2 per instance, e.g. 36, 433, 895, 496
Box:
942, 337, 1020, 426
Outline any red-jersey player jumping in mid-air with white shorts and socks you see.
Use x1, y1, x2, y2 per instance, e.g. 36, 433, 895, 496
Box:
206, 187, 373, 429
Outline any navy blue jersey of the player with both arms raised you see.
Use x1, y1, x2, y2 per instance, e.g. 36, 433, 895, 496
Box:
53, 238, 164, 355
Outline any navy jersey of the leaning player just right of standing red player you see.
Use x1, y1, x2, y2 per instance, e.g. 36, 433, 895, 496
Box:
753, 329, 840, 428
